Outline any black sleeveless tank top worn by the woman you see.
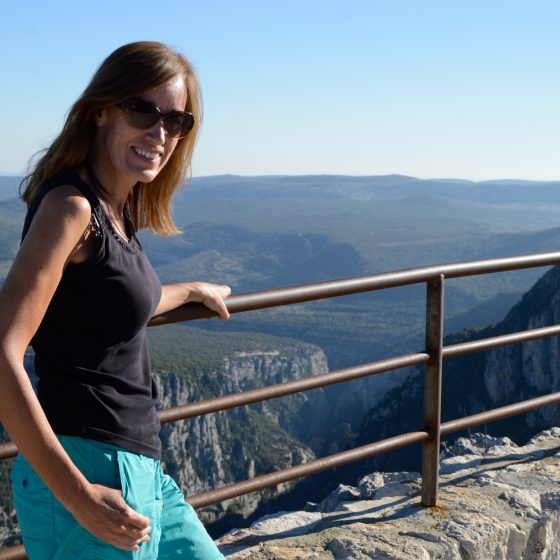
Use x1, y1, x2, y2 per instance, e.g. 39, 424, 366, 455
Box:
22, 171, 161, 459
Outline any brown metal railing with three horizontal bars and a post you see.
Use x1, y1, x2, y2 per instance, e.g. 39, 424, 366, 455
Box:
0, 252, 560, 560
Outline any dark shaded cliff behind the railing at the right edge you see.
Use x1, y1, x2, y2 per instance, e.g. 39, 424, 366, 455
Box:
355, 267, 560, 470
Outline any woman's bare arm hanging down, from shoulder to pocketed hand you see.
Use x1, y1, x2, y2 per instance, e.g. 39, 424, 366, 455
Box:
0, 186, 150, 550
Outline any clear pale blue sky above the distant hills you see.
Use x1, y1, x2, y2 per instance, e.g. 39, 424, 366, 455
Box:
0, 0, 560, 180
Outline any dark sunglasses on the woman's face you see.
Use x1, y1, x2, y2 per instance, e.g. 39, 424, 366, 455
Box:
117, 97, 194, 138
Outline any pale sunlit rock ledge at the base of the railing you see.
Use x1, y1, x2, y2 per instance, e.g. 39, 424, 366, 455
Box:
218, 428, 560, 560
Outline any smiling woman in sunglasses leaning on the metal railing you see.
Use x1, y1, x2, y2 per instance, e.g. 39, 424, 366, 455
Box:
0, 42, 230, 560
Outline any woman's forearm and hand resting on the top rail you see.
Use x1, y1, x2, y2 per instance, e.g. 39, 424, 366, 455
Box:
154, 282, 231, 320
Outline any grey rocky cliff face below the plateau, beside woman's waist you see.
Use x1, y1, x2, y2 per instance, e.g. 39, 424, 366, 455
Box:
155, 343, 327, 521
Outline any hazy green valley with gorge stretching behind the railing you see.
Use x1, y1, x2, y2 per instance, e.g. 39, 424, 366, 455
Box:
0, 176, 560, 534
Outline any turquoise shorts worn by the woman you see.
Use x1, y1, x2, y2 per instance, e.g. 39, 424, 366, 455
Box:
11, 436, 224, 560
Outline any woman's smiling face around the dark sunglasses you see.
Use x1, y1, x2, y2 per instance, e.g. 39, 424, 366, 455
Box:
94, 78, 187, 190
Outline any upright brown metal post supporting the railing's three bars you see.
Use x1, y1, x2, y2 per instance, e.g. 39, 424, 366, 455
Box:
422, 274, 444, 506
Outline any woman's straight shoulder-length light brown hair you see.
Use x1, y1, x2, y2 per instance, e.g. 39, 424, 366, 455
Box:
21, 41, 202, 235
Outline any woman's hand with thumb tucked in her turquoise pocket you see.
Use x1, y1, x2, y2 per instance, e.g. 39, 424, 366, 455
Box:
66, 484, 152, 551
